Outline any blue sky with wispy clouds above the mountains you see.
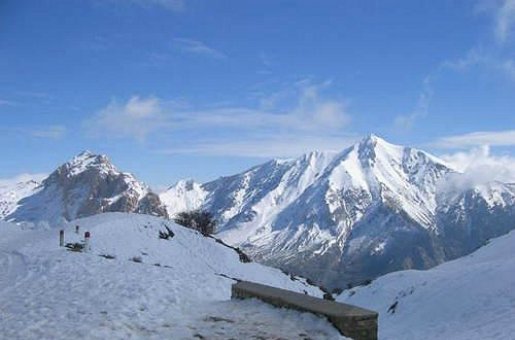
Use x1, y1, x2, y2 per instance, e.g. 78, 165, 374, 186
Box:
0, 0, 515, 188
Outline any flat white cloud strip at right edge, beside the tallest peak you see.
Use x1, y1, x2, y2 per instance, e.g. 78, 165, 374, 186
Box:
433, 130, 515, 148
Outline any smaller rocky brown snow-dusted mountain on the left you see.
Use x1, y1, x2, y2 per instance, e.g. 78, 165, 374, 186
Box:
4, 151, 167, 223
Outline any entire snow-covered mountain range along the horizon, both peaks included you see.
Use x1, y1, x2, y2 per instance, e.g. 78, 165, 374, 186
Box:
0, 135, 515, 288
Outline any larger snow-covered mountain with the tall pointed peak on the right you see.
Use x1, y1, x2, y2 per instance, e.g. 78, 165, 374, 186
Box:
161, 135, 515, 287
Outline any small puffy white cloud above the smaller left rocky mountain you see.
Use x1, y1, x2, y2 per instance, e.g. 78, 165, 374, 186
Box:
84, 96, 167, 141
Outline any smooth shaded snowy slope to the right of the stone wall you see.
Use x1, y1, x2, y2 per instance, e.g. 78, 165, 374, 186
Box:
337, 231, 515, 340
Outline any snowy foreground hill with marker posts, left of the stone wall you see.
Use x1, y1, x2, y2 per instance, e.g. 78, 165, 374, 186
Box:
0, 213, 341, 339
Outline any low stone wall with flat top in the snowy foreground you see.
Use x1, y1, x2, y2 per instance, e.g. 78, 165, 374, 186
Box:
232, 281, 378, 340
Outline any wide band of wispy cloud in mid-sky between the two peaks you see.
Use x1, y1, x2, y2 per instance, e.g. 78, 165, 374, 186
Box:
84, 81, 350, 157
